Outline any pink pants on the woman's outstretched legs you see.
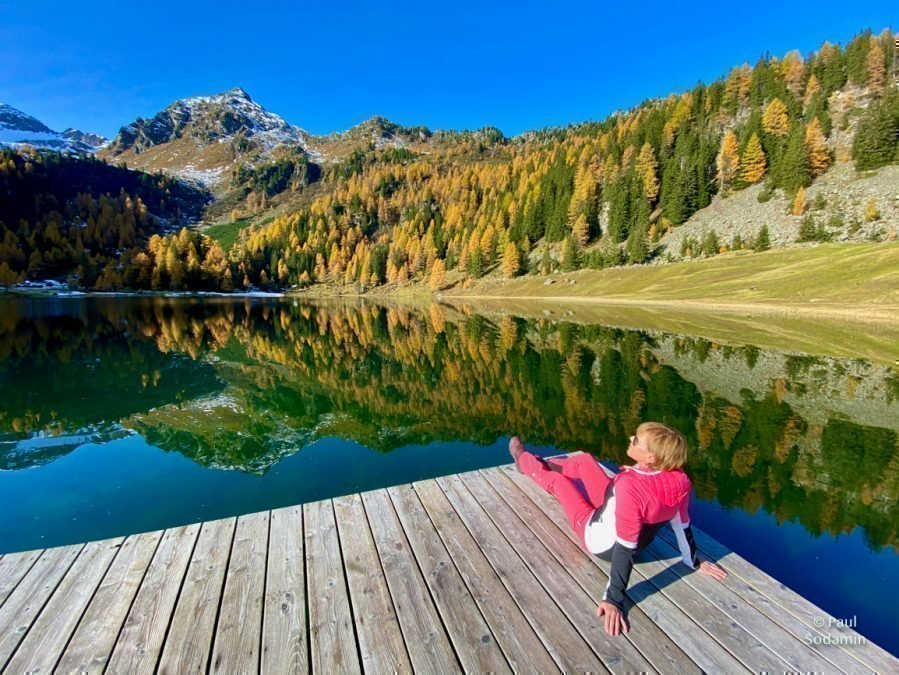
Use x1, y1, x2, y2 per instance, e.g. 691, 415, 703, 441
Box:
518, 450, 612, 549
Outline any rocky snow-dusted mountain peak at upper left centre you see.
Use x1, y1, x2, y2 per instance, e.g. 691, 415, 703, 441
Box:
101, 87, 308, 186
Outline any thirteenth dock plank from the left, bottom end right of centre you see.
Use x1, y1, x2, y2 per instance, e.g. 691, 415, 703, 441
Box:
413, 480, 559, 673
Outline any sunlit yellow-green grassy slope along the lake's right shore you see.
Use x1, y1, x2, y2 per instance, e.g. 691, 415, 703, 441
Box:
451, 242, 899, 308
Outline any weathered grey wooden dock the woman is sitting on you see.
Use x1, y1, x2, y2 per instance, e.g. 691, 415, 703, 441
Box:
0, 466, 899, 675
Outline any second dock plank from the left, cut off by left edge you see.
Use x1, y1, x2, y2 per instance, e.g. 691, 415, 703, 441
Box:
0, 544, 84, 668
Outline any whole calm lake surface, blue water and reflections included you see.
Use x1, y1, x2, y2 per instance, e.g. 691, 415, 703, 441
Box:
0, 297, 899, 653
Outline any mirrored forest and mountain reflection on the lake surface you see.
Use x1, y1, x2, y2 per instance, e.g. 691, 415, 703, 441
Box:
0, 298, 899, 550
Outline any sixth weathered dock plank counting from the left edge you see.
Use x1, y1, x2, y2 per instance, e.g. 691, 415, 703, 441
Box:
158, 518, 236, 673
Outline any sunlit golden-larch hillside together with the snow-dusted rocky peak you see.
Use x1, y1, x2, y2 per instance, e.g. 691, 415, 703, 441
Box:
1, 26, 899, 292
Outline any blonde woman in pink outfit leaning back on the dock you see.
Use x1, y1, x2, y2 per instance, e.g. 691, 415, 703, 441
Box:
509, 422, 727, 635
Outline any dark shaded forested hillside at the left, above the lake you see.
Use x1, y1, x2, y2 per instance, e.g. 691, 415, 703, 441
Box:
0, 149, 208, 289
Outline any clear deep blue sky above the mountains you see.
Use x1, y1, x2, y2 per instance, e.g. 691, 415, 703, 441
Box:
0, 0, 899, 136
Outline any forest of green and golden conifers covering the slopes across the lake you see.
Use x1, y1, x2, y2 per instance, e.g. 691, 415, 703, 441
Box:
0, 31, 899, 291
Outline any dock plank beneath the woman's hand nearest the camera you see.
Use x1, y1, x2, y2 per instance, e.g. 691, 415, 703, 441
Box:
482, 469, 701, 673
